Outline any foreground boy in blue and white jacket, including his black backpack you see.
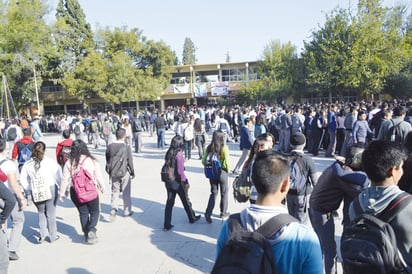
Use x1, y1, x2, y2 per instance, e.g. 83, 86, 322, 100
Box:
212, 151, 323, 274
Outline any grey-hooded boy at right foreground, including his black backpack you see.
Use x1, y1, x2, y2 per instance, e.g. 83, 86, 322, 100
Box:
341, 141, 412, 273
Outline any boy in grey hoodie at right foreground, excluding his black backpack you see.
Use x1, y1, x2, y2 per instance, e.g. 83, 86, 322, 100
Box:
349, 141, 412, 272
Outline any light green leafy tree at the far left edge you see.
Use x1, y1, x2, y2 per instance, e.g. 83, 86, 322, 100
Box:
0, 0, 54, 108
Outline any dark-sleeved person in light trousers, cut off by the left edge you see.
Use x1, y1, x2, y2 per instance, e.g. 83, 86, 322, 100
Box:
0, 182, 16, 274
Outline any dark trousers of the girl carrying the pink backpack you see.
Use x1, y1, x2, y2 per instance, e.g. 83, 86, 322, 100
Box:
70, 187, 100, 235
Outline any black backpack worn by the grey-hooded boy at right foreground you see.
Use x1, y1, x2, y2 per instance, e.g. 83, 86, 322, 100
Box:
341, 192, 412, 274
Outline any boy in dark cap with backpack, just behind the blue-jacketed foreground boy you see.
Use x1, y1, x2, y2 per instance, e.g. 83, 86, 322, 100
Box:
286, 132, 317, 224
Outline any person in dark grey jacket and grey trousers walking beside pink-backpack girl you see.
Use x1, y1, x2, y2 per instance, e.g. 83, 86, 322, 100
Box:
106, 128, 135, 222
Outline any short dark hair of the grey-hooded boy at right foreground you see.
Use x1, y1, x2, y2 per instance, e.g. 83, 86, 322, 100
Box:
362, 140, 407, 182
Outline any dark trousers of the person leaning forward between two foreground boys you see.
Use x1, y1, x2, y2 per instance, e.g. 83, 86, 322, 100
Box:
309, 208, 337, 274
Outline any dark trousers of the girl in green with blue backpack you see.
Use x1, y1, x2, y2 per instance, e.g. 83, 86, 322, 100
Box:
205, 170, 229, 216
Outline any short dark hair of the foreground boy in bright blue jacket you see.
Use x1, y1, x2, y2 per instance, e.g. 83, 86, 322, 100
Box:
252, 152, 289, 195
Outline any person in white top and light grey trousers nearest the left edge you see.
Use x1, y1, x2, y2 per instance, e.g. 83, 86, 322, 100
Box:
0, 138, 30, 261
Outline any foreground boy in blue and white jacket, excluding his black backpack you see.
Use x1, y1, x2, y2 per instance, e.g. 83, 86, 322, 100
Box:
217, 152, 323, 274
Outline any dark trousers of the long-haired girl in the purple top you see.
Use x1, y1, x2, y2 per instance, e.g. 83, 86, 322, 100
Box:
163, 183, 195, 229
